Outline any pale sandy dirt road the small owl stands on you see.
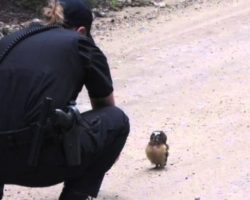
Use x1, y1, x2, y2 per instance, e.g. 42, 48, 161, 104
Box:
5, 0, 250, 200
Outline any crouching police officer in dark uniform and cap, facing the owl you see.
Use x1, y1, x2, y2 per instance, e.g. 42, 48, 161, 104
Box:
0, 0, 129, 200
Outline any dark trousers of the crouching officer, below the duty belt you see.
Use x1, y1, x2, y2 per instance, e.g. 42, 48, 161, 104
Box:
0, 107, 129, 200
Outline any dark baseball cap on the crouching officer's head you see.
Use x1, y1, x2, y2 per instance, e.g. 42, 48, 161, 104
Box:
59, 0, 93, 37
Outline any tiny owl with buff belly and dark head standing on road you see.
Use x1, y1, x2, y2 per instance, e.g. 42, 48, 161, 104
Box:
146, 131, 169, 168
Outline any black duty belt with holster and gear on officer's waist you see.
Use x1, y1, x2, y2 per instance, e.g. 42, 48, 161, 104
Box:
0, 97, 83, 167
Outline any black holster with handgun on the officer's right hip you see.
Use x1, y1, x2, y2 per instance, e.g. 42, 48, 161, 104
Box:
54, 105, 84, 166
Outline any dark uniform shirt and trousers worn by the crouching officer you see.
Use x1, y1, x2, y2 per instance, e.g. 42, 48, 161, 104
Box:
0, 25, 129, 196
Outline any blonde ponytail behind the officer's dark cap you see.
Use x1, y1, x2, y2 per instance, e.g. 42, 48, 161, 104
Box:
43, 0, 64, 25
